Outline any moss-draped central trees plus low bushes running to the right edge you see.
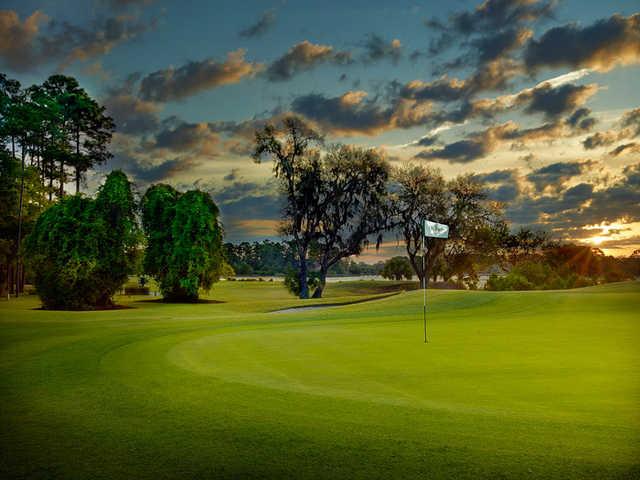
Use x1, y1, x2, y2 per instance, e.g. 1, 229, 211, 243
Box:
253, 117, 638, 298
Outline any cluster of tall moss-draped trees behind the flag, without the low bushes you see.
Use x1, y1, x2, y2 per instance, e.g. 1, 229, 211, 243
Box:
253, 117, 505, 298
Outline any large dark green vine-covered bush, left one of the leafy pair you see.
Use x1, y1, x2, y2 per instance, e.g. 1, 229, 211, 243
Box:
26, 171, 139, 310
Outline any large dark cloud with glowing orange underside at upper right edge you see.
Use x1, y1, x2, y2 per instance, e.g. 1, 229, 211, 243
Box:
524, 13, 640, 72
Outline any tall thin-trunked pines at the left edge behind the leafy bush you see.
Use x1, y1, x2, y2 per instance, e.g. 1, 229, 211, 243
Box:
0, 73, 115, 295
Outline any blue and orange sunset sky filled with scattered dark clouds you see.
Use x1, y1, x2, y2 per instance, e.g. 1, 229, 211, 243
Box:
0, 0, 640, 261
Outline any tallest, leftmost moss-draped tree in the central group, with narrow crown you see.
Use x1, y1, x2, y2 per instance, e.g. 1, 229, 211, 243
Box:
252, 117, 322, 298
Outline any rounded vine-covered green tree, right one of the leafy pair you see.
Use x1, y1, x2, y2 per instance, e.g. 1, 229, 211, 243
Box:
142, 184, 224, 302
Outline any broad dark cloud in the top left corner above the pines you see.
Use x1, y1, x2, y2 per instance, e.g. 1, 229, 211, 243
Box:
0, 10, 155, 72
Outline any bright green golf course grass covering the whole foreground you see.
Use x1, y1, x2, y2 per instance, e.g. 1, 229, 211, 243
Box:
0, 282, 640, 479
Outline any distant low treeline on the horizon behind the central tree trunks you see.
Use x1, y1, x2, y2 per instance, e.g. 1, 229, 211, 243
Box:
224, 240, 384, 276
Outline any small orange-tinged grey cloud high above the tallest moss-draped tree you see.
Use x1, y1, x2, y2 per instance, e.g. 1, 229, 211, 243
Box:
265, 40, 352, 82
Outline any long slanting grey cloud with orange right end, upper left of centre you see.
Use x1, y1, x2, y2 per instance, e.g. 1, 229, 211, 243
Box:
140, 49, 262, 102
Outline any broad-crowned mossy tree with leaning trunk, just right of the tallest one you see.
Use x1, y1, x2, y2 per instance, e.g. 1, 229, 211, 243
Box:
313, 146, 390, 298
